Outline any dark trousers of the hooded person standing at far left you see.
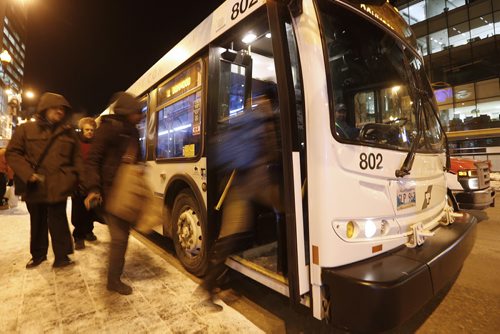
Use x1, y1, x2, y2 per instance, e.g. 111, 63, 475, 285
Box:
26, 201, 73, 260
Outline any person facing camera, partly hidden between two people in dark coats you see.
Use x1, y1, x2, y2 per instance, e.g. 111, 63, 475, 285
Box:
71, 117, 97, 250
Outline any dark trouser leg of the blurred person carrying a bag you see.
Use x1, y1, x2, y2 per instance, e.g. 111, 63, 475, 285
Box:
105, 214, 131, 282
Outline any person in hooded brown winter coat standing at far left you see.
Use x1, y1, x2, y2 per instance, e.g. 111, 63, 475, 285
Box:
6, 93, 82, 268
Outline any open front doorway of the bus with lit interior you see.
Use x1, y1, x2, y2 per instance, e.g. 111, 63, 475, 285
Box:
206, 2, 309, 305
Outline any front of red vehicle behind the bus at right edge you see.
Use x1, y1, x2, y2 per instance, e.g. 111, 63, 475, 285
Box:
446, 157, 495, 210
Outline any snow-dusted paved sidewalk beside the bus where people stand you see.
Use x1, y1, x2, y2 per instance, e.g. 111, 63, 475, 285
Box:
0, 202, 262, 333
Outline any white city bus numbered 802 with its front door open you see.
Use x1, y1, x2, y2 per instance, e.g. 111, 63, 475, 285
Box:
106, 0, 476, 331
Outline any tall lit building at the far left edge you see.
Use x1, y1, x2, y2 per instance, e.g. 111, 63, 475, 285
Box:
0, 0, 27, 145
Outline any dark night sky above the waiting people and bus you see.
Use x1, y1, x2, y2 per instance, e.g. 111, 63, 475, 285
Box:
24, 0, 223, 115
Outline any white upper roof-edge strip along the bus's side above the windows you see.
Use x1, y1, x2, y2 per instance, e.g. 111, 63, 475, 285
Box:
127, 0, 266, 96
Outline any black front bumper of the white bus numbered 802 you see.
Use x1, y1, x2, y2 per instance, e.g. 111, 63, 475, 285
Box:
322, 214, 477, 332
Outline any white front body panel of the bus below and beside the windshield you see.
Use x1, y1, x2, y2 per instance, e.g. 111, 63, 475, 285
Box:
294, 0, 446, 272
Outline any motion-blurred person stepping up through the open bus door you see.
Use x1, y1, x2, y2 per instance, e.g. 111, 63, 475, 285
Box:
196, 88, 283, 312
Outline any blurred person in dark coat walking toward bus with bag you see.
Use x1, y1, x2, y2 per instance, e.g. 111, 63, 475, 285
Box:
84, 93, 143, 295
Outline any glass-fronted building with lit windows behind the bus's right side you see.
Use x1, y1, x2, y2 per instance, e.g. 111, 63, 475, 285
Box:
395, 0, 500, 170
